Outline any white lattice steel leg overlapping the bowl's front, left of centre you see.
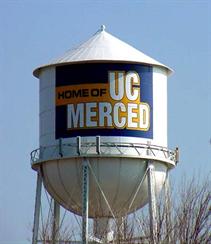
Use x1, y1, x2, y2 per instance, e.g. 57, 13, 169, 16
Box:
82, 158, 89, 244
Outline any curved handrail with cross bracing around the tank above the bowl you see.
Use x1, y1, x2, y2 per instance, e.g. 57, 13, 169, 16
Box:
31, 142, 179, 164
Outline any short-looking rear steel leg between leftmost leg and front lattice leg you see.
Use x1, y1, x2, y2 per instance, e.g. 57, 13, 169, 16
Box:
52, 200, 60, 244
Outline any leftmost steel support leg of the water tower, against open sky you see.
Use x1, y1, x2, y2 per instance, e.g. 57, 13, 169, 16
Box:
32, 170, 42, 244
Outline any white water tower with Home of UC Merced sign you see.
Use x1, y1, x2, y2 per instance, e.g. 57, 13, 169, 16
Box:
31, 26, 177, 243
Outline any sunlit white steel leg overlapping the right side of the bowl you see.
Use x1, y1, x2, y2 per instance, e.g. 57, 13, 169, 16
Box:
148, 160, 157, 244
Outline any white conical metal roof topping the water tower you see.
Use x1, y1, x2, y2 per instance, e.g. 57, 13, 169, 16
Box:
33, 25, 172, 77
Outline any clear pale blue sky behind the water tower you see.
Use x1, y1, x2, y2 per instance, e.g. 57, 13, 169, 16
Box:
0, 0, 211, 244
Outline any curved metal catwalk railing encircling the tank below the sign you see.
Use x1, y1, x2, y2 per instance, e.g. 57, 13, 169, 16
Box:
31, 137, 179, 165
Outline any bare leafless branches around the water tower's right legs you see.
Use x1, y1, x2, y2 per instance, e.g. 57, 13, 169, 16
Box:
129, 175, 211, 244
